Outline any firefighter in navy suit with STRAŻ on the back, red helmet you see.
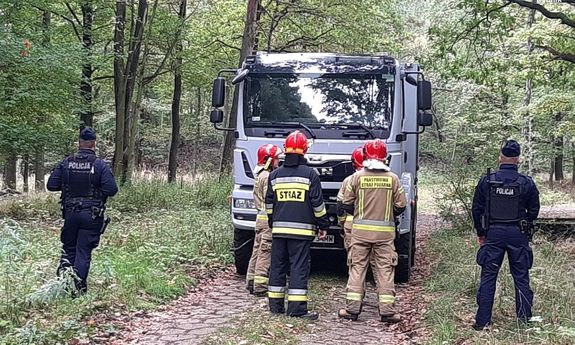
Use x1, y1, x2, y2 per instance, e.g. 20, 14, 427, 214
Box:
265, 131, 329, 320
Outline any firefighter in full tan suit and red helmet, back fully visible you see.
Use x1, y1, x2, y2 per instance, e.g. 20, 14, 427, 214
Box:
338, 139, 407, 322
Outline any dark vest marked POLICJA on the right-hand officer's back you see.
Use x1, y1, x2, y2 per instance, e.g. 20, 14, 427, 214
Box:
489, 176, 527, 223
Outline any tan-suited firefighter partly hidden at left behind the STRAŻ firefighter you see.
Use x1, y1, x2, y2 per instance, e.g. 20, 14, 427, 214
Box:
247, 144, 281, 297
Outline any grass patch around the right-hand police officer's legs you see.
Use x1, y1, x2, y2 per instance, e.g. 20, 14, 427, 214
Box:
425, 230, 575, 344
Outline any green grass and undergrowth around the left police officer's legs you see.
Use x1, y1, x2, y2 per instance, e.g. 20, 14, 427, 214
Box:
0, 176, 232, 344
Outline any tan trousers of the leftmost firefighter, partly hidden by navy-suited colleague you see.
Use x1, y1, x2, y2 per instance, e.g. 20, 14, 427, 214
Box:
246, 220, 272, 293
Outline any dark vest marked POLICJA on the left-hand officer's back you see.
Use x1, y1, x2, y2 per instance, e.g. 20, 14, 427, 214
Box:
62, 153, 102, 202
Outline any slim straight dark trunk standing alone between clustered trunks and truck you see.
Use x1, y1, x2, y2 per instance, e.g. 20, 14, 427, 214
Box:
168, 0, 187, 182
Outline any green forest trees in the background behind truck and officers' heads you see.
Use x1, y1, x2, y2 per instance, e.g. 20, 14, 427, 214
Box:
0, 0, 575, 190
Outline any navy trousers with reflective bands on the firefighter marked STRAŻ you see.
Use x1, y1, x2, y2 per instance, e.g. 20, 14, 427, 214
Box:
268, 237, 311, 316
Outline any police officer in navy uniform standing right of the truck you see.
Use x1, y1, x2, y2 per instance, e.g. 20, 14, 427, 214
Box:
472, 140, 539, 331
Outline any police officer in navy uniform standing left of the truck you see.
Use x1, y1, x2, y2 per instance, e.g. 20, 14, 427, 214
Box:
47, 128, 118, 294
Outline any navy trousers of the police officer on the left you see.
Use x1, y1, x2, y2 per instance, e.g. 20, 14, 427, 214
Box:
58, 209, 104, 292
